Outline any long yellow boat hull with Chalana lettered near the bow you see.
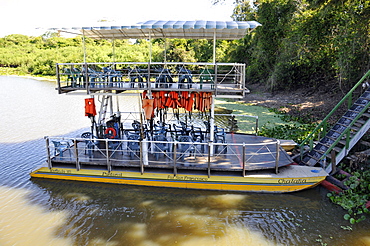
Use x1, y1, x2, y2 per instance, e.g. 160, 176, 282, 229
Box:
31, 166, 327, 193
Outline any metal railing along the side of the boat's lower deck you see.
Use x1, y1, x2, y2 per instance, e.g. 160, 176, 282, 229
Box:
45, 137, 280, 176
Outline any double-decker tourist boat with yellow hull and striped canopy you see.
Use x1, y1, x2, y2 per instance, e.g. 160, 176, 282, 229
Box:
31, 21, 327, 193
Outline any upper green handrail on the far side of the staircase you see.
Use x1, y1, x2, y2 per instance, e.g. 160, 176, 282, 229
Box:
299, 70, 370, 156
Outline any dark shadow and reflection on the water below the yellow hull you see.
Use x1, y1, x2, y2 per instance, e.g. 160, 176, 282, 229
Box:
28, 179, 366, 245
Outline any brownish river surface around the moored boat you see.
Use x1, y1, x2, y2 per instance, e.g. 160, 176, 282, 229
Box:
0, 76, 370, 246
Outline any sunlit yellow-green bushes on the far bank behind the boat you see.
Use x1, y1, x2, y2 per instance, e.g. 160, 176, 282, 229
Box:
0, 33, 225, 76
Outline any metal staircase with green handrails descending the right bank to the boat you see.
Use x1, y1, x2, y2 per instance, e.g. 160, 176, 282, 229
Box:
300, 70, 370, 173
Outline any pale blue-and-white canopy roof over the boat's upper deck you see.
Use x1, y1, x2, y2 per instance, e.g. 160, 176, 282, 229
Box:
58, 20, 261, 40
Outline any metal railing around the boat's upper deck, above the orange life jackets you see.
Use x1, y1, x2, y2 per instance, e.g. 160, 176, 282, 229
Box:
56, 62, 245, 97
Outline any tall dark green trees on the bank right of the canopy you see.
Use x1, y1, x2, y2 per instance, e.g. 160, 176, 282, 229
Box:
228, 0, 370, 90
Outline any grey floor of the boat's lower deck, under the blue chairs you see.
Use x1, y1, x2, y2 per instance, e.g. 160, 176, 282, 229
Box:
51, 133, 293, 171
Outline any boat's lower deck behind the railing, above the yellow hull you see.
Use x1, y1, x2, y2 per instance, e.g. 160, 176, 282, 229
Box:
50, 133, 293, 171
